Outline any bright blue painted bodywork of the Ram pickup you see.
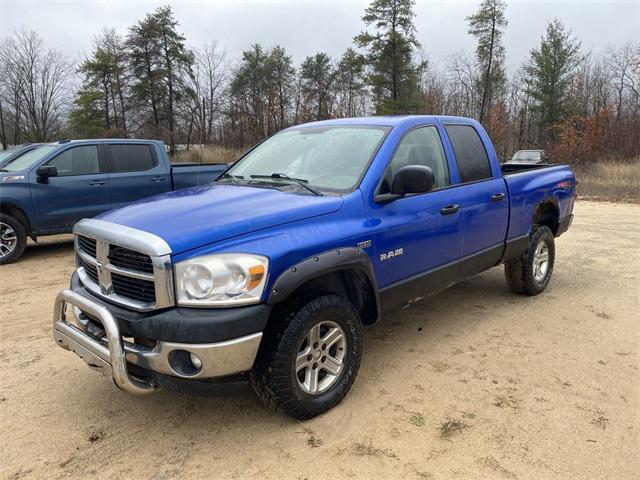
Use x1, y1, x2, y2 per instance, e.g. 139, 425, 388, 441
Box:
101, 116, 575, 295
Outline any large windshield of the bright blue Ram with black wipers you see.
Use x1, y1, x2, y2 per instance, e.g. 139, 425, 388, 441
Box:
225, 125, 389, 192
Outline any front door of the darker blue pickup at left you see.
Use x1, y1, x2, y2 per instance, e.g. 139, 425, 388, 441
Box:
30, 144, 111, 232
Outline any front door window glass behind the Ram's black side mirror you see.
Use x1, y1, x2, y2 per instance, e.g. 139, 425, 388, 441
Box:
389, 127, 451, 190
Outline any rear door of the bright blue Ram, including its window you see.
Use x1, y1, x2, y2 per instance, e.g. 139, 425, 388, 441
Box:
445, 124, 509, 278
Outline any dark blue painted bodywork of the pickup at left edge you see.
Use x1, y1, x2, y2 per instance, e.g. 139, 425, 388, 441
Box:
0, 139, 226, 236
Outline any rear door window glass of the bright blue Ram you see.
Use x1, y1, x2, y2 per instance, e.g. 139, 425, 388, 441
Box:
444, 125, 493, 183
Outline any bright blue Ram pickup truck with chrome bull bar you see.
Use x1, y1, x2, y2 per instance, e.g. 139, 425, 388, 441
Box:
53, 116, 575, 419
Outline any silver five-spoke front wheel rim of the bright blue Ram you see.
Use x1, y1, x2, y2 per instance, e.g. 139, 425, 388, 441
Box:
296, 321, 347, 395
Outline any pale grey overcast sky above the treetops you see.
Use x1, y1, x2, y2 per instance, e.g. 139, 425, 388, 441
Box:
0, 0, 640, 69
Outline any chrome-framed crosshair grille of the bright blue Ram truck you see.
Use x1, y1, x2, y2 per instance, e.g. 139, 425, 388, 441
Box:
74, 219, 174, 311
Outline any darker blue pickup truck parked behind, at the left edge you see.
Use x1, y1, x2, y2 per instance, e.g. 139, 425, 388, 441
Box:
0, 139, 227, 265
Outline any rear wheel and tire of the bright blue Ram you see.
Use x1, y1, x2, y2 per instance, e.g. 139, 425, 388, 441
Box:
504, 226, 556, 295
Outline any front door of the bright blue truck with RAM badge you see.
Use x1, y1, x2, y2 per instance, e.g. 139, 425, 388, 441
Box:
370, 126, 462, 309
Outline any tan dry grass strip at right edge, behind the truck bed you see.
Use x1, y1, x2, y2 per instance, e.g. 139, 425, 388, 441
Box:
576, 159, 640, 203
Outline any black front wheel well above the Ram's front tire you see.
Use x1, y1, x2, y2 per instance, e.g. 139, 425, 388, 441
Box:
272, 269, 378, 325
